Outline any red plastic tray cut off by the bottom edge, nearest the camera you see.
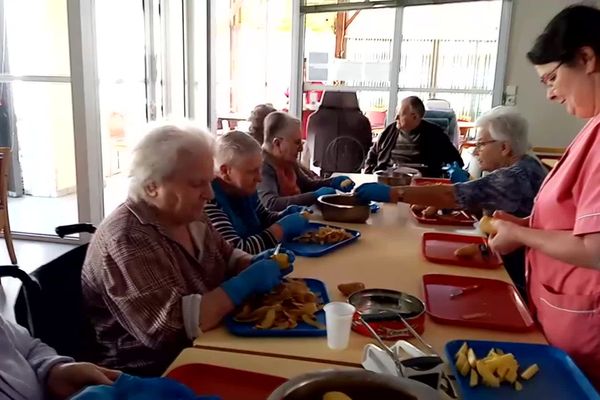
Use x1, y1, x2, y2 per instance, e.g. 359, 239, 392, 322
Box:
167, 364, 287, 400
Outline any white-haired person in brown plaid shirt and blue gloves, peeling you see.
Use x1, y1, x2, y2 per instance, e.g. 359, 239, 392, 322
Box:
82, 125, 293, 375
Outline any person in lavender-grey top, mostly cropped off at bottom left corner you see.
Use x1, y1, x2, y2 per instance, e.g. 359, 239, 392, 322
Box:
0, 315, 120, 400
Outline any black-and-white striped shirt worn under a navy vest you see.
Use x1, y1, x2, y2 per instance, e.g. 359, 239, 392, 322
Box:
204, 199, 281, 254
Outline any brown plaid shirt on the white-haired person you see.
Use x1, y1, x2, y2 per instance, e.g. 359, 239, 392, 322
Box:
82, 200, 239, 374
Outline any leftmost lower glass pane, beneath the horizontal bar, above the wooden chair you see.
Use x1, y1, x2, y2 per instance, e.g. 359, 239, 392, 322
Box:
1, 82, 79, 235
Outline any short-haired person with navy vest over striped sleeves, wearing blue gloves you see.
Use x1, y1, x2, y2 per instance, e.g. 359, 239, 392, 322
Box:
204, 131, 309, 254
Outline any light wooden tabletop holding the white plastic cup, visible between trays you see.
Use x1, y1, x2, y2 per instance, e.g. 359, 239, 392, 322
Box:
194, 175, 546, 366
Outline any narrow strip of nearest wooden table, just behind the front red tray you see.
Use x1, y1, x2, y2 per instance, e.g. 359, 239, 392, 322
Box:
164, 348, 352, 378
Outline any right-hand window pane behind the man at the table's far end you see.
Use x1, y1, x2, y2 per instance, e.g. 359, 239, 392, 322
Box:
398, 0, 502, 120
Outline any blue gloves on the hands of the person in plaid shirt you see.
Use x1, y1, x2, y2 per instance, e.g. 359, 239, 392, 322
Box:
221, 249, 296, 306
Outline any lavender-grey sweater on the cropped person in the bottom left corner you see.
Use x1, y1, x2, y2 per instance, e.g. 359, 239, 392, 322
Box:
0, 315, 73, 400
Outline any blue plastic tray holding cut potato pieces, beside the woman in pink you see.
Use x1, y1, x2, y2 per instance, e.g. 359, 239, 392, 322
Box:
446, 340, 600, 400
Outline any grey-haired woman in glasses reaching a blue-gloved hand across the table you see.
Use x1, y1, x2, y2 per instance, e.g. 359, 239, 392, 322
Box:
356, 106, 546, 291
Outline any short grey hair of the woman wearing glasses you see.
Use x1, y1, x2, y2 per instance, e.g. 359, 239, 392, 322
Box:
475, 106, 531, 156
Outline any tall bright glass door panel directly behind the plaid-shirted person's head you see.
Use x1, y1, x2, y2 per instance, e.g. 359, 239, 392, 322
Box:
95, 0, 185, 215
